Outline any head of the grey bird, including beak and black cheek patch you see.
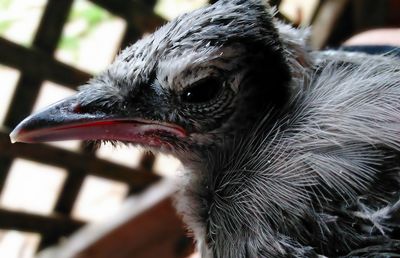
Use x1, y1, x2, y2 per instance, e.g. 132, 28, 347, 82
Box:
11, 0, 291, 159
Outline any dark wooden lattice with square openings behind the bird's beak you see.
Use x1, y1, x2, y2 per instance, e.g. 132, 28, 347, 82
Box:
0, 0, 164, 252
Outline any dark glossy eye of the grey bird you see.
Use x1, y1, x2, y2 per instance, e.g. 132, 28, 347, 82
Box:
181, 78, 222, 103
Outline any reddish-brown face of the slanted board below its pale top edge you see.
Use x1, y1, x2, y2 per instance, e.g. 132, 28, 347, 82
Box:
74, 198, 194, 258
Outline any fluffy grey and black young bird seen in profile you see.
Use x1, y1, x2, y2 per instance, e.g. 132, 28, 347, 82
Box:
10, 0, 400, 258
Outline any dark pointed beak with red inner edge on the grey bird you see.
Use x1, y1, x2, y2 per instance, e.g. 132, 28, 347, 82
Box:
10, 96, 186, 146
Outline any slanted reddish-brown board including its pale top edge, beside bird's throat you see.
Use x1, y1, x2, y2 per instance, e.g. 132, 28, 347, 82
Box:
38, 179, 194, 258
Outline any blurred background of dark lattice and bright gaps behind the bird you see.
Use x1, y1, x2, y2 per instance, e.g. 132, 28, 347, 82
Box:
0, 0, 400, 258
